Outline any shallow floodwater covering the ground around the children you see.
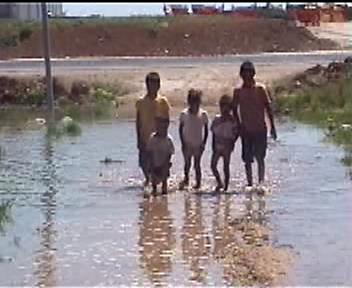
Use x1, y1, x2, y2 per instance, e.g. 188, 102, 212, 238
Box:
0, 120, 352, 286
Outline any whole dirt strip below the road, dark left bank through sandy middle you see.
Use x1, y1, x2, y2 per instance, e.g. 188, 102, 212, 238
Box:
0, 63, 309, 118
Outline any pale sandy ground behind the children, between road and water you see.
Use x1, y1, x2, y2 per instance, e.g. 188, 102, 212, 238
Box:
52, 63, 310, 118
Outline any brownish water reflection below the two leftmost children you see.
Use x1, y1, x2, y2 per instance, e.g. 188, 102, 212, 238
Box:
139, 196, 176, 285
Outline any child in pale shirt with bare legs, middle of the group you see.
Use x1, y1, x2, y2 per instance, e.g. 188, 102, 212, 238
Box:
179, 89, 208, 190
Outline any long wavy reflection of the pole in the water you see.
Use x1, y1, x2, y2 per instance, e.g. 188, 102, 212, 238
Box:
35, 136, 58, 286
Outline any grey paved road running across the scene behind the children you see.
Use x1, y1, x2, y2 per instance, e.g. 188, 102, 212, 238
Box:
0, 51, 352, 75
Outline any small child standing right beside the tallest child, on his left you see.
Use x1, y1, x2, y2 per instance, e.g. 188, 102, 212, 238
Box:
210, 95, 239, 191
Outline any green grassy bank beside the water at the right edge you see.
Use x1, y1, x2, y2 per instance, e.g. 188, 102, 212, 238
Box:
275, 78, 352, 164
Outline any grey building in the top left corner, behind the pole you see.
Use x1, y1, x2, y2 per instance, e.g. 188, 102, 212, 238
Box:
0, 2, 63, 21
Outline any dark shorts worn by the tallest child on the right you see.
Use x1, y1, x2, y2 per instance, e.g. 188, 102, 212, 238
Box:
241, 131, 267, 163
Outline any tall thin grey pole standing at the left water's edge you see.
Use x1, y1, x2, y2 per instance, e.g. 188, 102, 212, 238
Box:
41, 2, 54, 120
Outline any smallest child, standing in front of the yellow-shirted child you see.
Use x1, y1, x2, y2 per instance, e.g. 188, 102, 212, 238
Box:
147, 116, 175, 195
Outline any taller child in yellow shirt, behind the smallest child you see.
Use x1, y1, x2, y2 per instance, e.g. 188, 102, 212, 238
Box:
136, 72, 170, 186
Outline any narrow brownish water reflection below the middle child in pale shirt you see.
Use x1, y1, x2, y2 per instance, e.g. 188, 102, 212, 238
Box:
181, 194, 210, 285
